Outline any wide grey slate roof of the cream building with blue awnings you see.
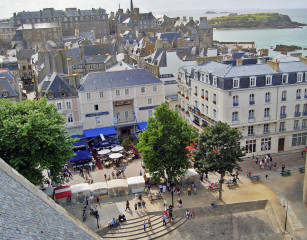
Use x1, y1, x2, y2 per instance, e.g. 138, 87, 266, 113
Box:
78, 69, 162, 92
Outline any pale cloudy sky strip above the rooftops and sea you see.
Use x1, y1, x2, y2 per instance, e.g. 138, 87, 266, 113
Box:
0, 0, 307, 19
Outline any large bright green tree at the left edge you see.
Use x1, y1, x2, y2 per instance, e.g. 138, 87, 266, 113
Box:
0, 99, 74, 185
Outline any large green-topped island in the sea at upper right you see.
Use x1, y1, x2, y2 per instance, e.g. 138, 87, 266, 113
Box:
208, 13, 306, 29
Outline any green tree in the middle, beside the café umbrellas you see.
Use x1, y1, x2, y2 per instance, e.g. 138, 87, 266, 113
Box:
137, 103, 197, 181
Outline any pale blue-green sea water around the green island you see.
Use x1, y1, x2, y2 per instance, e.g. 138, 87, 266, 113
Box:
158, 8, 307, 57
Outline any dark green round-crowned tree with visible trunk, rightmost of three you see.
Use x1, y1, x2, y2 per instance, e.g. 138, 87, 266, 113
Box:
195, 122, 244, 199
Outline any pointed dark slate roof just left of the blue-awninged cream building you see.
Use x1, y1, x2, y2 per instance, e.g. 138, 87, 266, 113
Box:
42, 72, 78, 99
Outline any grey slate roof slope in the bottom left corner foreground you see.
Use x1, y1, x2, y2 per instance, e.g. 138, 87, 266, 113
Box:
0, 159, 101, 240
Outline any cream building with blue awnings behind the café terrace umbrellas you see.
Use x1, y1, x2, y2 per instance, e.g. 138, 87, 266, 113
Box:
78, 69, 165, 137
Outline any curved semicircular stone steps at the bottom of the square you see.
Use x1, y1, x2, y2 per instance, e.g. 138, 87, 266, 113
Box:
102, 215, 186, 240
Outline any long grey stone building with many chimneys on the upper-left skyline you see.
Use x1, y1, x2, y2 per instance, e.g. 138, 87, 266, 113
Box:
13, 8, 109, 39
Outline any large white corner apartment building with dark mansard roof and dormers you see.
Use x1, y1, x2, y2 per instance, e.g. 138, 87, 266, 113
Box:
178, 59, 307, 156
